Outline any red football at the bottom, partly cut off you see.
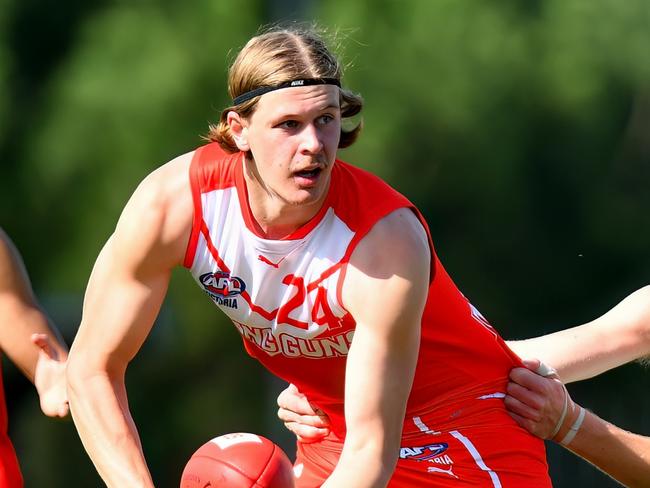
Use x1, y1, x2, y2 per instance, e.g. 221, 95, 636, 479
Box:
181, 433, 294, 488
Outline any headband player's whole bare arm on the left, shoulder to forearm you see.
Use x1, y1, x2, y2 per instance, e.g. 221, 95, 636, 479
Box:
67, 157, 192, 488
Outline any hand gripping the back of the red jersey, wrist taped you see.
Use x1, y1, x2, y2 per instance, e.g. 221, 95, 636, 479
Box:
504, 359, 577, 439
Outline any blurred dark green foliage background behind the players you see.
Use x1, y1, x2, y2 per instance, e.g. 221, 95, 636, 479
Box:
0, 0, 650, 487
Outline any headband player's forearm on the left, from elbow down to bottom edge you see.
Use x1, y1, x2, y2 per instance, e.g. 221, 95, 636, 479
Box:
68, 365, 153, 488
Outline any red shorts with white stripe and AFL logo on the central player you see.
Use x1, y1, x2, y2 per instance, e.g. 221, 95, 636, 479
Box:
294, 423, 552, 488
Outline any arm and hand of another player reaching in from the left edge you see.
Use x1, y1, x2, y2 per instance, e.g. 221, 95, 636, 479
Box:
0, 229, 68, 416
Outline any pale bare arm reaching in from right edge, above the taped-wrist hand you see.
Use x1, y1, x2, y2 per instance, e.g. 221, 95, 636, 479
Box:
508, 286, 650, 383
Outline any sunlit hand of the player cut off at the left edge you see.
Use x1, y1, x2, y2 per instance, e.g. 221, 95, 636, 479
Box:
31, 334, 70, 417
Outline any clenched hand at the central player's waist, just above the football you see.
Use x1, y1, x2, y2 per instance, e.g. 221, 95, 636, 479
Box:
278, 384, 330, 444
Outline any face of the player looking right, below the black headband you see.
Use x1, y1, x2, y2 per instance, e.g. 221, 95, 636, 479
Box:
238, 85, 341, 205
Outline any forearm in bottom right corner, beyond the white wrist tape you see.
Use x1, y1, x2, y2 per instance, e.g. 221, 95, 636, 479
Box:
568, 412, 650, 488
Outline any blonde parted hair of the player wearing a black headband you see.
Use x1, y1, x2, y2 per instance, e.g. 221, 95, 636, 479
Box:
206, 27, 363, 153
